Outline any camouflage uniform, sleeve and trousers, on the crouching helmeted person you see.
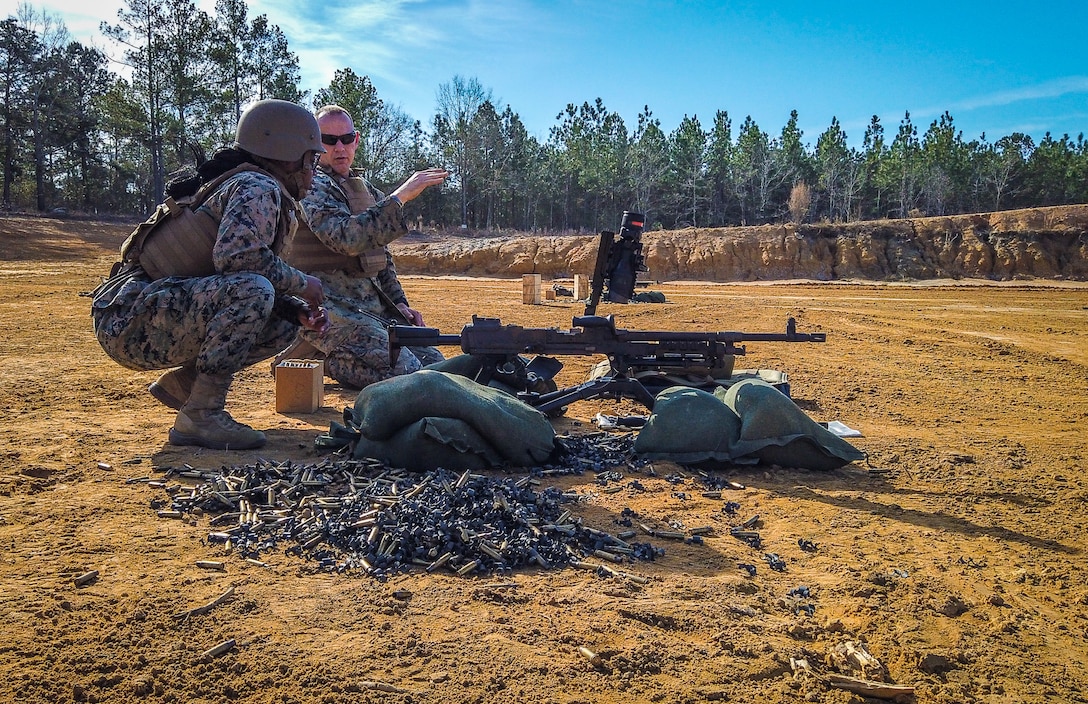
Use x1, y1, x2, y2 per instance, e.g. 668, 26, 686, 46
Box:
91, 171, 306, 375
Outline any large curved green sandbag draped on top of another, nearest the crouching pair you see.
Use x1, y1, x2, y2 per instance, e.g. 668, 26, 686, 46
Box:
354, 369, 555, 467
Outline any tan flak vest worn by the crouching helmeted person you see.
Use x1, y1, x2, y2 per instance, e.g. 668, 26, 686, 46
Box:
114, 163, 301, 279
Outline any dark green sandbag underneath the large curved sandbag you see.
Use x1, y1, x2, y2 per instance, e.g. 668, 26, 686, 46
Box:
353, 418, 503, 472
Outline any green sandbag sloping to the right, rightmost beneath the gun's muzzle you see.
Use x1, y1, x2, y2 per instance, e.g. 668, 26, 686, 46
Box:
714, 380, 865, 471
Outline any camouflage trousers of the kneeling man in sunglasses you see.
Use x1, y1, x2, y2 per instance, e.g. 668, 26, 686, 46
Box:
302, 317, 445, 388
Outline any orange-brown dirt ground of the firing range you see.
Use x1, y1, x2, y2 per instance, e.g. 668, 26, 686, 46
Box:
0, 220, 1088, 704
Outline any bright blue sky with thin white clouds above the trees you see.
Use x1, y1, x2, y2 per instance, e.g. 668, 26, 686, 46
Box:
10, 0, 1088, 148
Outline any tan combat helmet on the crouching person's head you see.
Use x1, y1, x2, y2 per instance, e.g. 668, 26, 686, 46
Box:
234, 99, 325, 161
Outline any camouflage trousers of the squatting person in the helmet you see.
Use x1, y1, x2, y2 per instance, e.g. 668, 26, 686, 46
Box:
92, 272, 298, 375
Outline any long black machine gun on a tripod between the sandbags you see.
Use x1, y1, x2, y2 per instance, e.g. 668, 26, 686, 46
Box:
388, 316, 826, 413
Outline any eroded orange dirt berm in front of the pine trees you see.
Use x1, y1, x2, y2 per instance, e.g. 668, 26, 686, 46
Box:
394, 205, 1088, 282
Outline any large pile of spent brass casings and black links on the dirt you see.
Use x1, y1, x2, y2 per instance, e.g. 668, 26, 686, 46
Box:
152, 434, 662, 579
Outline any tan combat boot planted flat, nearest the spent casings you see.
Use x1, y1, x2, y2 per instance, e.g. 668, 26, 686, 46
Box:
170, 374, 265, 449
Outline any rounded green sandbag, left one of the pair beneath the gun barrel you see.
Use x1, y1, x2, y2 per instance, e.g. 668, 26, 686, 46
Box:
634, 386, 741, 465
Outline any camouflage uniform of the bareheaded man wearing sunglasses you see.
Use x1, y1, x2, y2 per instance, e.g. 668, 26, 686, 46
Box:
295, 166, 443, 388
